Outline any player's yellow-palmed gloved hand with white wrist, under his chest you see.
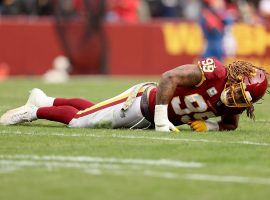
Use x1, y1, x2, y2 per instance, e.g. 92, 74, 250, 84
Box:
188, 120, 219, 132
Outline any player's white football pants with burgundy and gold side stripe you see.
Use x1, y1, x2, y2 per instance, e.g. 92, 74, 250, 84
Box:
69, 85, 151, 128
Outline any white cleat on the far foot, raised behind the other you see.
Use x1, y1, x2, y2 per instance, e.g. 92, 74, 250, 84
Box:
25, 88, 54, 108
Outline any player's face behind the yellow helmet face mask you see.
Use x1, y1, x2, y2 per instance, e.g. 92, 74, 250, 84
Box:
220, 82, 252, 107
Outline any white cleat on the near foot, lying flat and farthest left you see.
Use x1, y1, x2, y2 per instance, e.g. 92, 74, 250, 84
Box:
0, 105, 37, 125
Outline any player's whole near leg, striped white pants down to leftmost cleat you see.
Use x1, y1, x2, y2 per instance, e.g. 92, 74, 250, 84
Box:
0, 83, 151, 128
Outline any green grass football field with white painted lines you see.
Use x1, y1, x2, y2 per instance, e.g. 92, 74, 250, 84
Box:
0, 77, 270, 200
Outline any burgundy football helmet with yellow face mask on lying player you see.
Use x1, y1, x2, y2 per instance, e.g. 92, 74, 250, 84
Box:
220, 69, 267, 107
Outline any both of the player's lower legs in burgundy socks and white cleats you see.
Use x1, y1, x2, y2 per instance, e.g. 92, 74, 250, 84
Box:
0, 88, 93, 125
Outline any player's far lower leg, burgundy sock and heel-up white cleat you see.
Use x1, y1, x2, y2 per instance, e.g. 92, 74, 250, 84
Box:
26, 88, 94, 110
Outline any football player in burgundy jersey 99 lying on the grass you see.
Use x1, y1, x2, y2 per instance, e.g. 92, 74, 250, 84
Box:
0, 58, 267, 132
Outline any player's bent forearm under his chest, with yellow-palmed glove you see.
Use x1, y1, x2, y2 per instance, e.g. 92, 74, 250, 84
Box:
189, 114, 240, 132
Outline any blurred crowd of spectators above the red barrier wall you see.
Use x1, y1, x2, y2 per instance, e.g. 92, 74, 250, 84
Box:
0, 0, 270, 23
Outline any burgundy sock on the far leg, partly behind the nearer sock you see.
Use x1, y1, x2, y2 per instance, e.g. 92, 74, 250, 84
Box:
53, 98, 95, 110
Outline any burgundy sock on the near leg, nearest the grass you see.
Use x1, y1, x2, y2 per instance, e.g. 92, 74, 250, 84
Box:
37, 106, 78, 124
